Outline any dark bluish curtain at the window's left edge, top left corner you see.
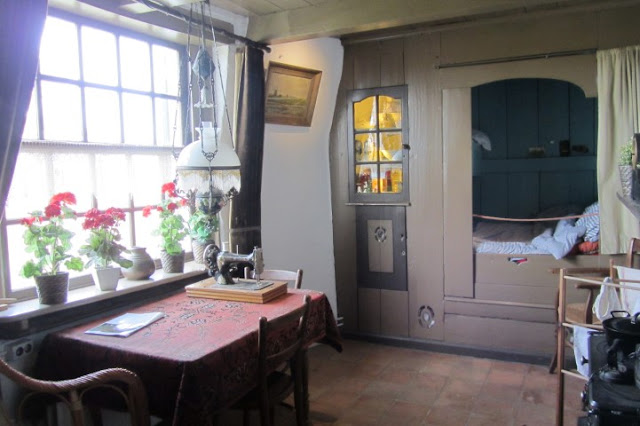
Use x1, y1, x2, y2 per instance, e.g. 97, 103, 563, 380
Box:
0, 0, 47, 220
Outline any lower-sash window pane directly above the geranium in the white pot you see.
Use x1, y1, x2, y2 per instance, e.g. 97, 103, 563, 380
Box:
96, 154, 131, 210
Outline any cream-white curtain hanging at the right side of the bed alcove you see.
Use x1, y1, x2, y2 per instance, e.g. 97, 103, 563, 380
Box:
597, 46, 640, 254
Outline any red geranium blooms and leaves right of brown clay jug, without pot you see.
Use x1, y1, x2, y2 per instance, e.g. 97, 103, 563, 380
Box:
142, 182, 187, 254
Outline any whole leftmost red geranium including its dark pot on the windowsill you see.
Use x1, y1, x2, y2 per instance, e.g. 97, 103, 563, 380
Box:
20, 192, 83, 305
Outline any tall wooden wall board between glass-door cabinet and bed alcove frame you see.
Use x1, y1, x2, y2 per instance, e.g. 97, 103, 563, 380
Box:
404, 34, 444, 340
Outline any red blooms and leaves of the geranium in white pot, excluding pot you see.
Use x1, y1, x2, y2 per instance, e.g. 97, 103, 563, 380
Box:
80, 207, 133, 268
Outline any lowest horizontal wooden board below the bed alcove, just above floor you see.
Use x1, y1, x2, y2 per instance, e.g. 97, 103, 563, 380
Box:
445, 314, 556, 355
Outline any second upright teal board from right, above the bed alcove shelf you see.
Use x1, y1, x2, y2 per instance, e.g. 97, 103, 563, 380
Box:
538, 79, 569, 157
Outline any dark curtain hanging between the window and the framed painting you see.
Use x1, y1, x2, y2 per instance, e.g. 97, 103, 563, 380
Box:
229, 47, 265, 253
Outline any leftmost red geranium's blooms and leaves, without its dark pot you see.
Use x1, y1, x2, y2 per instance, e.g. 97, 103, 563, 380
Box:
20, 192, 83, 278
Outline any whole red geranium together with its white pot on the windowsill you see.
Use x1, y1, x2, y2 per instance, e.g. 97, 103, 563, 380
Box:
79, 207, 133, 291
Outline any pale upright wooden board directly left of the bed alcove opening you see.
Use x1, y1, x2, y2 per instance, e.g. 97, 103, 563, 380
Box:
442, 89, 473, 297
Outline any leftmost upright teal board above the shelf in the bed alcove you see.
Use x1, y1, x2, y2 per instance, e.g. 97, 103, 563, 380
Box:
472, 81, 507, 159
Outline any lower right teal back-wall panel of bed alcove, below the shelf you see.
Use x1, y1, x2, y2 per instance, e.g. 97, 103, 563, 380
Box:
540, 170, 598, 209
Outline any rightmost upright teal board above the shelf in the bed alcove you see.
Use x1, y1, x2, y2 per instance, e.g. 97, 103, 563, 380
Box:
569, 85, 597, 156
